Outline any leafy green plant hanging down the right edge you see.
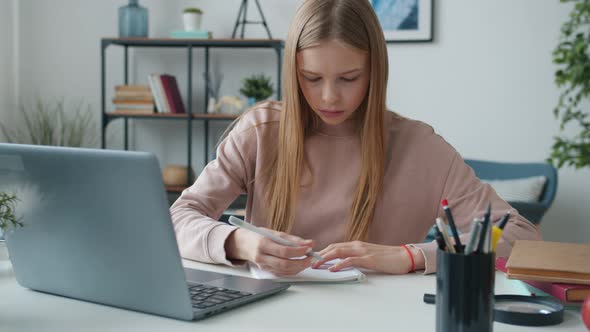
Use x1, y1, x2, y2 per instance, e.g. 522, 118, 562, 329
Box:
548, 0, 590, 169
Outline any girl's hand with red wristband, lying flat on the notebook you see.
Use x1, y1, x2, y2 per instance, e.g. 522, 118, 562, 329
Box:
312, 241, 424, 274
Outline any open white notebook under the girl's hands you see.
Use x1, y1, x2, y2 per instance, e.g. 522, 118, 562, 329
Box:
250, 259, 365, 283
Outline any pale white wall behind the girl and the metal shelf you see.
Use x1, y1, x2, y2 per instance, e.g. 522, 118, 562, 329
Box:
5, 0, 590, 242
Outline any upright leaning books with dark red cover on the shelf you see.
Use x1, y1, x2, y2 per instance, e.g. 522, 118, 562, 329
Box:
148, 74, 186, 114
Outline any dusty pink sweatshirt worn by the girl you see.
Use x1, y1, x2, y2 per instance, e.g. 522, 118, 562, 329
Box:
171, 103, 541, 273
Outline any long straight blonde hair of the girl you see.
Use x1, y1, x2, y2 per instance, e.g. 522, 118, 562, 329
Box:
266, 0, 388, 241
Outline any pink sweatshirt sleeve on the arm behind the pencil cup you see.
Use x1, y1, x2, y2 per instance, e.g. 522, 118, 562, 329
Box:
413, 150, 541, 274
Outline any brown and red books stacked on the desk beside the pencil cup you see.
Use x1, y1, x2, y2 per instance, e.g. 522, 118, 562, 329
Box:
496, 240, 590, 304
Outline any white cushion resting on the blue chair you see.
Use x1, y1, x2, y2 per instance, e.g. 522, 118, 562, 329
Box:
481, 176, 547, 203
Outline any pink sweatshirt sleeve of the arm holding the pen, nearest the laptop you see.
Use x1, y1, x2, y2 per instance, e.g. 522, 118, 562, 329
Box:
170, 119, 256, 265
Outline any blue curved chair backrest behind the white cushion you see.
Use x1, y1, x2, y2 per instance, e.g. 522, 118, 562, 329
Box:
465, 159, 557, 224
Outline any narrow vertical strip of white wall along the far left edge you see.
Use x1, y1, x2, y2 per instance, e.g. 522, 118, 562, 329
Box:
0, 0, 15, 123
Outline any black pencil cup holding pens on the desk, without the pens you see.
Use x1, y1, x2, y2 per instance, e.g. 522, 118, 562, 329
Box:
436, 250, 495, 332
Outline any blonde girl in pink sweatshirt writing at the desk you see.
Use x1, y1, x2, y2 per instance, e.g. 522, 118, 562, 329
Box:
171, 0, 540, 275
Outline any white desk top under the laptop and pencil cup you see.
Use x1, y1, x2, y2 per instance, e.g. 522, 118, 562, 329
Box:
0, 261, 585, 332
